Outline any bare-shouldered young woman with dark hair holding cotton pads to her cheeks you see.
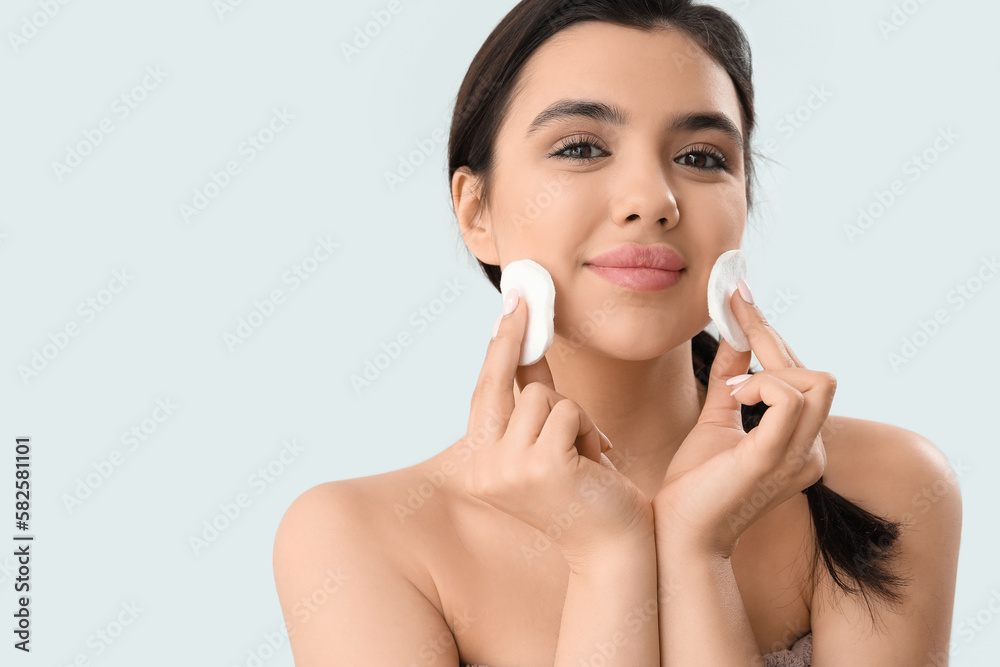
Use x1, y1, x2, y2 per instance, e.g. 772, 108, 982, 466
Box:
274, 0, 961, 667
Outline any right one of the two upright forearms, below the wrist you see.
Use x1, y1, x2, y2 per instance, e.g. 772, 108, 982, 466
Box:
656, 526, 764, 667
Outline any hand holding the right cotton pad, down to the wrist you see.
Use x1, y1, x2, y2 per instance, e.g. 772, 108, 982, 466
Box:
652, 282, 837, 557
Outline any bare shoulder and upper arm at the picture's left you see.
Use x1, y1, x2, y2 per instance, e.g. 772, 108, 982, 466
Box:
272, 471, 457, 667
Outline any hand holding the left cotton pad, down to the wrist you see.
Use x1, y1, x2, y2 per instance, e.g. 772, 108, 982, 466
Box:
465, 288, 653, 566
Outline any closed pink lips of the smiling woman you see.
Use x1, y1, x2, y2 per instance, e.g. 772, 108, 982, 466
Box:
584, 243, 684, 292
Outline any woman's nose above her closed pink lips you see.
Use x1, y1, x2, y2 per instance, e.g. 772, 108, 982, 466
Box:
612, 155, 680, 229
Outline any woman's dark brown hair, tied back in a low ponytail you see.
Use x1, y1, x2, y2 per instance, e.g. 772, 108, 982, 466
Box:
448, 0, 906, 619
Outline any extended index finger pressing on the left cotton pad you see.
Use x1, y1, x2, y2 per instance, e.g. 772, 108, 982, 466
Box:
468, 298, 528, 443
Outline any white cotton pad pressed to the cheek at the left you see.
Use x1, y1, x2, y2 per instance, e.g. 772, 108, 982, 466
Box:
500, 259, 556, 366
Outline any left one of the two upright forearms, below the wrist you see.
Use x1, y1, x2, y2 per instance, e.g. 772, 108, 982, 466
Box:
554, 526, 660, 667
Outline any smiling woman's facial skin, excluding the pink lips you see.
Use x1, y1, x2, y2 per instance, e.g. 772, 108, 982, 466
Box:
458, 21, 746, 360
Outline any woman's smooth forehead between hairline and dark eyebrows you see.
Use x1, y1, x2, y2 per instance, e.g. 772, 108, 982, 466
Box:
505, 21, 742, 133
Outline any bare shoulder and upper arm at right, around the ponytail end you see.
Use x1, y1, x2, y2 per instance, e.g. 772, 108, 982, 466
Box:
810, 416, 962, 665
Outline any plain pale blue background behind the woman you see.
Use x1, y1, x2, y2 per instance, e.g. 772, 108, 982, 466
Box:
0, 0, 1000, 667
